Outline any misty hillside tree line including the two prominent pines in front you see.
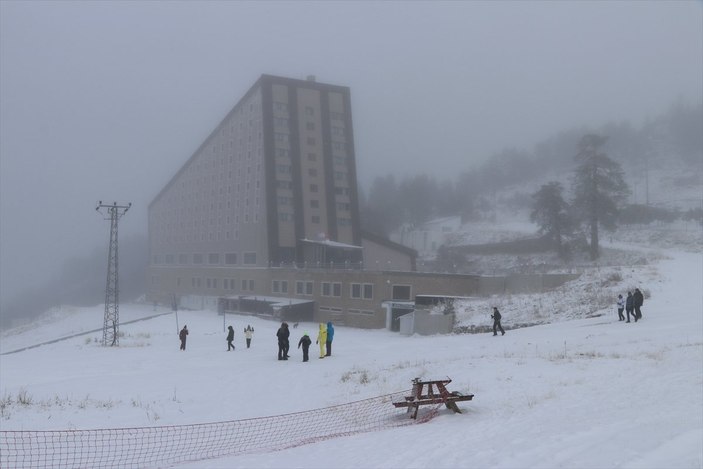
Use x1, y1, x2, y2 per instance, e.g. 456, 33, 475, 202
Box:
359, 102, 703, 256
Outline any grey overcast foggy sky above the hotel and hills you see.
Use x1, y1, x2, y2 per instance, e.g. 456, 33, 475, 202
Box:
0, 0, 703, 306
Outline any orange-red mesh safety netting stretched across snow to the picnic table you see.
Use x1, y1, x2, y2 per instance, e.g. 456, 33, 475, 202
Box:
0, 391, 441, 469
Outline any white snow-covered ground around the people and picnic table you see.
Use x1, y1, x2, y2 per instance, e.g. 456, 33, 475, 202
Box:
0, 239, 703, 468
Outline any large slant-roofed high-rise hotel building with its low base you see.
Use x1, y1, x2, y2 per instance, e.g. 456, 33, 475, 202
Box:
147, 75, 484, 327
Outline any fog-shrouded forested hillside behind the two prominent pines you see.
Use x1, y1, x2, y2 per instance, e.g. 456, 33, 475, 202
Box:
360, 101, 703, 235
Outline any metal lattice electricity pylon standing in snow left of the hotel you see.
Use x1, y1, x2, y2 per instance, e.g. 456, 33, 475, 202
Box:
95, 200, 132, 346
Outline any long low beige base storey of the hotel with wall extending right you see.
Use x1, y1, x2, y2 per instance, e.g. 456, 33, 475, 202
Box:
148, 266, 578, 331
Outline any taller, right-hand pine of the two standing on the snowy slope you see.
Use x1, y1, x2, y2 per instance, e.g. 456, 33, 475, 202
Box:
573, 134, 630, 260
